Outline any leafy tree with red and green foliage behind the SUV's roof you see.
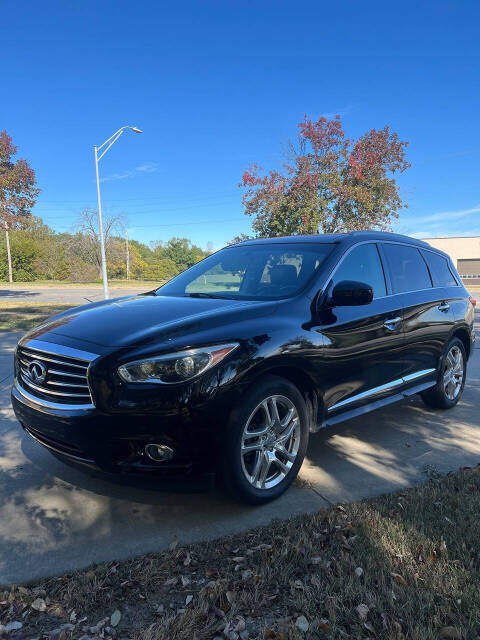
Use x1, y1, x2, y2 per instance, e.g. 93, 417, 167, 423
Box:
240, 116, 410, 237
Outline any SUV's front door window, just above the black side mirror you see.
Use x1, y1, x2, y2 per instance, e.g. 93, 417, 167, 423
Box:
329, 244, 386, 298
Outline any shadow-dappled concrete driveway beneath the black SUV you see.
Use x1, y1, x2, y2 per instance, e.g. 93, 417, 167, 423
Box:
0, 316, 480, 584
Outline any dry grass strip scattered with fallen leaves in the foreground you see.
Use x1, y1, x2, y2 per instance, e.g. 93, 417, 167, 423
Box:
0, 467, 480, 640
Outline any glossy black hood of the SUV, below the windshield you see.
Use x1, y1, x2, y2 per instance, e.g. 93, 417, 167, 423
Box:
22, 294, 276, 347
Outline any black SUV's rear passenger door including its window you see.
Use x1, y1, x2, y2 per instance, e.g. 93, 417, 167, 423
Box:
382, 242, 455, 384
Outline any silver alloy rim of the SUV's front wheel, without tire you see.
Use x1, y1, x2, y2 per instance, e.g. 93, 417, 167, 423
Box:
240, 395, 301, 489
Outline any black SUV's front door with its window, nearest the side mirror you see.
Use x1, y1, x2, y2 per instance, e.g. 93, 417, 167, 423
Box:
316, 242, 404, 413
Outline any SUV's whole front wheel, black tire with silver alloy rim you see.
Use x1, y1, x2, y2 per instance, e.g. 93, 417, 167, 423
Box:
220, 376, 309, 505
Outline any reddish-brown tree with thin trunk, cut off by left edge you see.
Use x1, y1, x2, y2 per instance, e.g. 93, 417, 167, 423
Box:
0, 131, 40, 282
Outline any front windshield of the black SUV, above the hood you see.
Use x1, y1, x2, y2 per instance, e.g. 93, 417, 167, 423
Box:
156, 242, 334, 300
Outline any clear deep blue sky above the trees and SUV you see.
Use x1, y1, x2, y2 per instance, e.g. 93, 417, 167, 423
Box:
0, 0, 480, 248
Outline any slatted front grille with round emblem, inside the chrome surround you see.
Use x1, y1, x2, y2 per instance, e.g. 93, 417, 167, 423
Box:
17, 345, 92, 405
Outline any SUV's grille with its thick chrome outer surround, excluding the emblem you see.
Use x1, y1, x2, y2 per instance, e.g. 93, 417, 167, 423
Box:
16, 340, 98, 409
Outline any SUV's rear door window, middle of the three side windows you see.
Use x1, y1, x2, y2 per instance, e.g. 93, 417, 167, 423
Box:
383, 243, 432, 293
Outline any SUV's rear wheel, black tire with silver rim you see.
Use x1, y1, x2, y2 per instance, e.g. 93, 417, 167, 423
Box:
420, 338, 467, 409
